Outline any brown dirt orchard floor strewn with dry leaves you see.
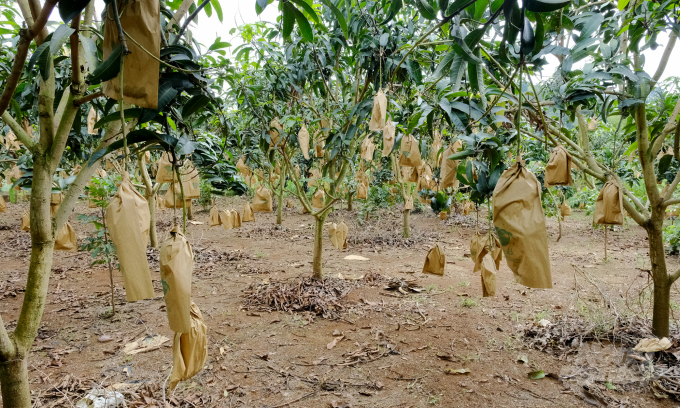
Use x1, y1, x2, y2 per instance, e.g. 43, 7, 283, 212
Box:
0, 197, 680, 408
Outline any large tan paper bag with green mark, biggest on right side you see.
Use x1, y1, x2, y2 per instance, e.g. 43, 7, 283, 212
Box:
493, 163, 552, 289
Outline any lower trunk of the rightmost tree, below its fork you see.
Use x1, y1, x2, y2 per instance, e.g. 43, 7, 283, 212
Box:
647, 222, 672, 337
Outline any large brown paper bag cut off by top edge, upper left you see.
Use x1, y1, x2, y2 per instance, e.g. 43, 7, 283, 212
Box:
102, 0, 161, 109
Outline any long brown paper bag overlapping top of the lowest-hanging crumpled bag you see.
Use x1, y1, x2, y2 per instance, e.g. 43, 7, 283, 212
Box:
160, 227, 194, 333
